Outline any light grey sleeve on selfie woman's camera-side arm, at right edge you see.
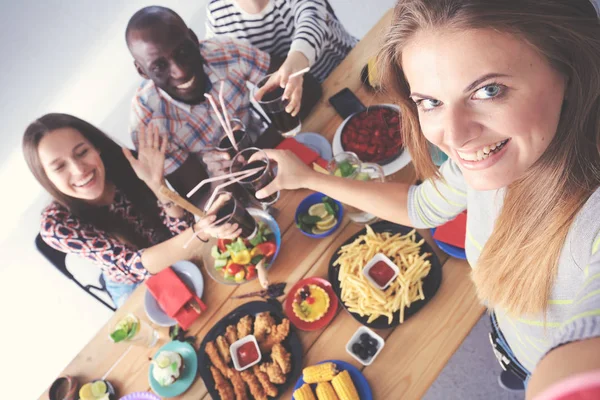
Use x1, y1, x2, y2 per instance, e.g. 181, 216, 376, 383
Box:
550, 234, 600, 349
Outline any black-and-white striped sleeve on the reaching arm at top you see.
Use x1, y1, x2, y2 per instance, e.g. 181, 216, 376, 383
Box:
290, 0, 329, 66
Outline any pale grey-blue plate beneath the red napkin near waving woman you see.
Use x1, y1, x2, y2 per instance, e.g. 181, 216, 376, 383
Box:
144, 260, 204, 326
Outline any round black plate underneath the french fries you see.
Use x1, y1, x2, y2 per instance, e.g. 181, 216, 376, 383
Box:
329, 221, 442, 329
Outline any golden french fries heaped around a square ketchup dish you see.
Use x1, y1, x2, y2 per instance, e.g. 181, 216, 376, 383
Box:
334, 225, 431, 324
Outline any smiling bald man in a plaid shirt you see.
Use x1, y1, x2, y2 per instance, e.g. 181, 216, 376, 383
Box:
126, 6, 270, 203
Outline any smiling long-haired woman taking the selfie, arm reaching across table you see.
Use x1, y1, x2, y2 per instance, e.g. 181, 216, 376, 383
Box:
252, 0, 600, 395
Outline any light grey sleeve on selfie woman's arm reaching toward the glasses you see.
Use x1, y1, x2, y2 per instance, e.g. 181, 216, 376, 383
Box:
408, 160, 467, 229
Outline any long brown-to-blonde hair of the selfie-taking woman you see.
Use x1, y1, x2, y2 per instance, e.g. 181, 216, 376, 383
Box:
378, 0, 600, 316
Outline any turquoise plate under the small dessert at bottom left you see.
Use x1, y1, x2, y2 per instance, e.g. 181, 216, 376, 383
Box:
148, 341, 198, 397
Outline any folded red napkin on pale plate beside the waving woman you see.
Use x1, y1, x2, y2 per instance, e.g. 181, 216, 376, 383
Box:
146, 267, 206, 329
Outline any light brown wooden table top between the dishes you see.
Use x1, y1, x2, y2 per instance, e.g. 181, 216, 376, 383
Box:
40, 11, 483, 400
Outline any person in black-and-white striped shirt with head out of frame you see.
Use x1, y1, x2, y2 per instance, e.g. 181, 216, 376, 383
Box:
206, 0, 357, 115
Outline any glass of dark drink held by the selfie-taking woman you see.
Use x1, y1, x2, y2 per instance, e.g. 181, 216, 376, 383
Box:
230, 147, 279, 207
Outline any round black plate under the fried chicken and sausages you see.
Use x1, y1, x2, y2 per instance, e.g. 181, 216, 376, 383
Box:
198, 301, 302, 400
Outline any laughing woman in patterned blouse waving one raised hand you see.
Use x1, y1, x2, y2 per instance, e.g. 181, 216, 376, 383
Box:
23, 114, 240, 306
